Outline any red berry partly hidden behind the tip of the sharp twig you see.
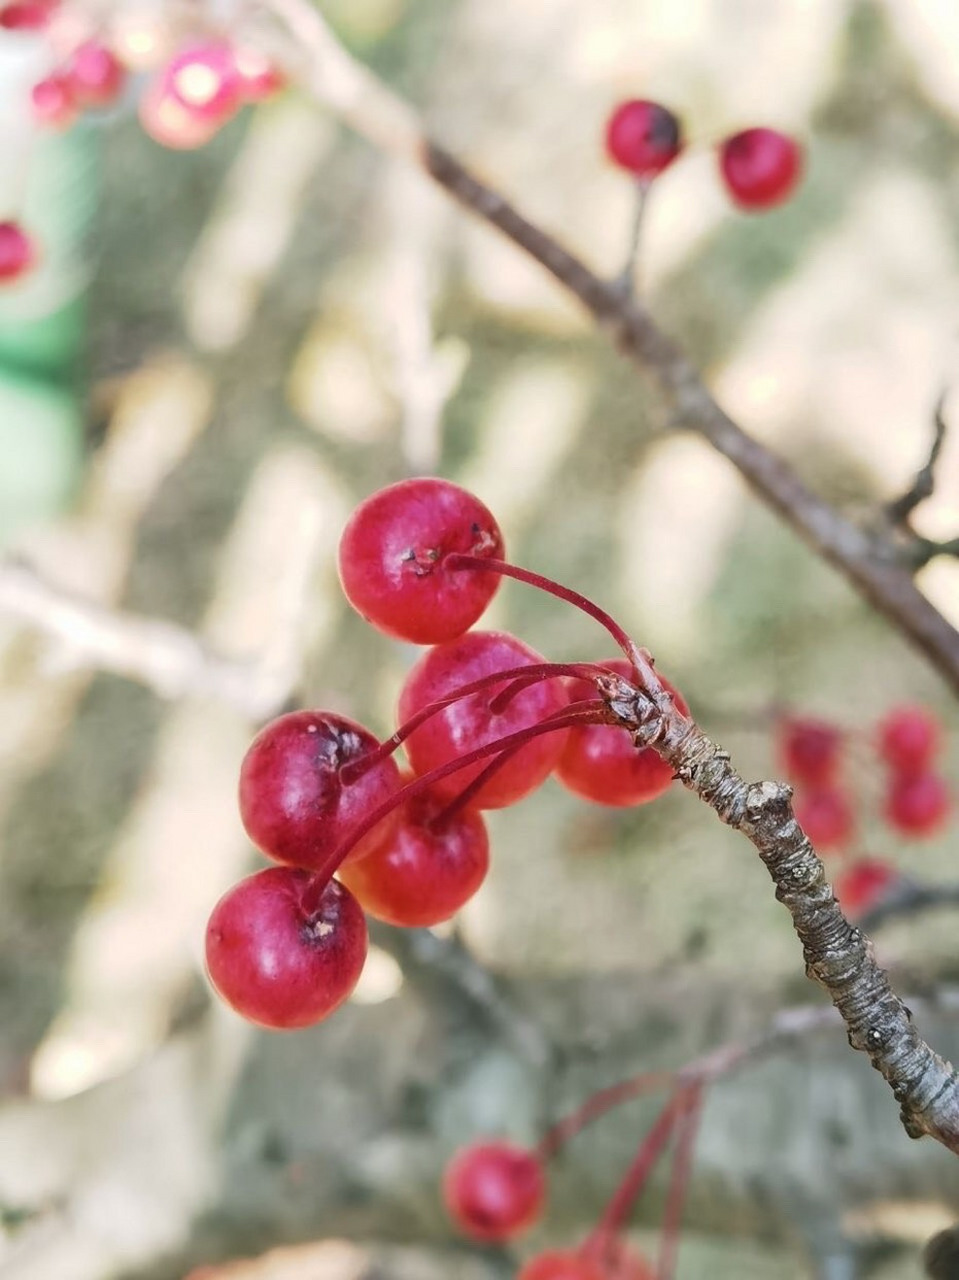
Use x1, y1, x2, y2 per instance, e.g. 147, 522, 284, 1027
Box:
556, 658, 689, 808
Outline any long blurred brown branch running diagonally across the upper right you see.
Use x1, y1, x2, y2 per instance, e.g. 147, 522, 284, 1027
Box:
268, 0, 959, 691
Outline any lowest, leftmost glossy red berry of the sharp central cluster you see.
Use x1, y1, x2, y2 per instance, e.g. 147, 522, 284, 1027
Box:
206, 867, 366, 1030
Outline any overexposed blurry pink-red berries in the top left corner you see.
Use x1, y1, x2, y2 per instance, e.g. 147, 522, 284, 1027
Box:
0, 10, 283, 285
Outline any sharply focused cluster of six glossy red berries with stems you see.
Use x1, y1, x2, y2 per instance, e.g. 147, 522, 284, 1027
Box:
206, 477, 688, 1028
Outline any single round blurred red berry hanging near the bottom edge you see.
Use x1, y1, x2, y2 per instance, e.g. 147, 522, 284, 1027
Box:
443, 1142, 545, 1240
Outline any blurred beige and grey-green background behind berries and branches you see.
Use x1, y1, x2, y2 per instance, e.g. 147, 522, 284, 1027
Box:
0, 0, 959, 1280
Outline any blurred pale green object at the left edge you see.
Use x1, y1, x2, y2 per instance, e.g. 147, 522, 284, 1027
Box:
0, 33, 100, 545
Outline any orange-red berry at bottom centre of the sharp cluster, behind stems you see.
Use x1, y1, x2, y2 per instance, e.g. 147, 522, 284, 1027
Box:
339, 792, 489, 928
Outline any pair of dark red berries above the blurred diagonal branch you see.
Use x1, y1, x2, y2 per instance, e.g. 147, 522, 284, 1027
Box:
606, 99, 803, 210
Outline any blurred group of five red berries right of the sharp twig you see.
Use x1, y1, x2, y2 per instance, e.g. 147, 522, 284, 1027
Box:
778, 705, 951, 915
